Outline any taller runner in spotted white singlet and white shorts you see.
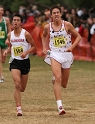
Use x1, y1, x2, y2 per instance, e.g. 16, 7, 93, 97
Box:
42, 5, 81, 115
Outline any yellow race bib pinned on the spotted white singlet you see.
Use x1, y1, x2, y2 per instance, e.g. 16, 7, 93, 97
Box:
54, 37, 66, 47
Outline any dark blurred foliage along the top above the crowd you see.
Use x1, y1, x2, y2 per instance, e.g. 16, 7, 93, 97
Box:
0, 0, 95, 12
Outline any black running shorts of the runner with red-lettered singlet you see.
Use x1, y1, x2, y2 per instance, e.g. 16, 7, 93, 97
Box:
9, 58, 30, 75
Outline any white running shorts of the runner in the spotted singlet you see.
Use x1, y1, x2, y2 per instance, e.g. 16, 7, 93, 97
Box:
44, 51, 74, 68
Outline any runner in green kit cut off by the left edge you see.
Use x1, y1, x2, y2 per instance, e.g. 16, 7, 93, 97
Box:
0, 5, 11, 83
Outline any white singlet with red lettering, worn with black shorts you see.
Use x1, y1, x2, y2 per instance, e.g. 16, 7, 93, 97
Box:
10, 29, 30, 60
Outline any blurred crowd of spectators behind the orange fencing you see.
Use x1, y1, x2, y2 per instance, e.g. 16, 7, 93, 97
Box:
5, 4, 95, 41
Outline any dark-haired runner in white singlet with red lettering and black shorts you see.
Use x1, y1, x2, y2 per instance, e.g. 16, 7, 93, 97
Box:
4, 14, 35, 116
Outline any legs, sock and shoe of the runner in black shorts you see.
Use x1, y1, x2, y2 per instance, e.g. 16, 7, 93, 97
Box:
11, 69, 28, 116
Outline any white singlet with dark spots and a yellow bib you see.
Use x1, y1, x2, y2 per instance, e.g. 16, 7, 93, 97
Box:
49, 21, 72, 52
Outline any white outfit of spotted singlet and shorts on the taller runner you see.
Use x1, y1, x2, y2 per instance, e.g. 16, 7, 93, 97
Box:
44, 21, 73, 68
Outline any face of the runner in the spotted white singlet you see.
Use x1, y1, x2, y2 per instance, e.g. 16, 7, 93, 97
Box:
51, 8, 62, 21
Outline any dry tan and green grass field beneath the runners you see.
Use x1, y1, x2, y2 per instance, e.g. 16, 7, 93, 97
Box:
0, 56, 95, 124
